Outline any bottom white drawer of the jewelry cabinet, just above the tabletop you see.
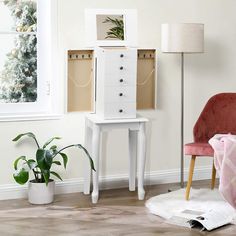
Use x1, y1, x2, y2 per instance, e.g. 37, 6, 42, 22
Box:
104, 102, 136, 119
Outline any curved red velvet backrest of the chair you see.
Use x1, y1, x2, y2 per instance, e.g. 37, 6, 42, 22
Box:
193, 93, 236, 142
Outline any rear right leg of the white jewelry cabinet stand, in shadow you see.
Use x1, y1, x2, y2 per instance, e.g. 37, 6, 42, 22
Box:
129, 129, 137, 191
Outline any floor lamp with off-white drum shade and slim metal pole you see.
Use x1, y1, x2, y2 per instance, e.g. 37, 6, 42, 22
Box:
162, 23, 204, 188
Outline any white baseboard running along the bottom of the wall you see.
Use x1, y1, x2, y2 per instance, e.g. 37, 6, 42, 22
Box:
0, 166, 212, 200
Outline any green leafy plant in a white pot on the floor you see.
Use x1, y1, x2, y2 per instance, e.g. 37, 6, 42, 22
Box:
12, 132, 95, 204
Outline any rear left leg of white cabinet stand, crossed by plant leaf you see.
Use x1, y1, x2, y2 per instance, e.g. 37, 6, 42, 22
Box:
84, 119, 92, 194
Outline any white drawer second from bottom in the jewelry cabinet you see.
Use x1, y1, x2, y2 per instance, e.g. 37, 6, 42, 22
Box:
104, 86, 136, 102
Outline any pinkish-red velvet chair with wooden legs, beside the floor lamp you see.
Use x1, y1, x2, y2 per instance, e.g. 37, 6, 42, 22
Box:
184, 93, 236, 200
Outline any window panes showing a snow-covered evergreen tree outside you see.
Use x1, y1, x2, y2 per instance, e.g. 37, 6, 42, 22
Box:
0, 0, 37, 103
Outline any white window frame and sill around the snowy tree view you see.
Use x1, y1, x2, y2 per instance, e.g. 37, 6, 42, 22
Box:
0, 0, 61, 121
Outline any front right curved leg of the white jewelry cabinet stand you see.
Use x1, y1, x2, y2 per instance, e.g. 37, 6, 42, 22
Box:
138, 123, 146, 200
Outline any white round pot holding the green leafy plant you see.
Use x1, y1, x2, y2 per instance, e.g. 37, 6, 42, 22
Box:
28, 180, 55, 204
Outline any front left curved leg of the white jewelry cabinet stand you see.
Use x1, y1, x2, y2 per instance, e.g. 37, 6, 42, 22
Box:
92, 125, 100, 203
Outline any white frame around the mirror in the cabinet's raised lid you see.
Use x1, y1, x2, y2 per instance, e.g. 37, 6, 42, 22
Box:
85, 9, 138, 47
